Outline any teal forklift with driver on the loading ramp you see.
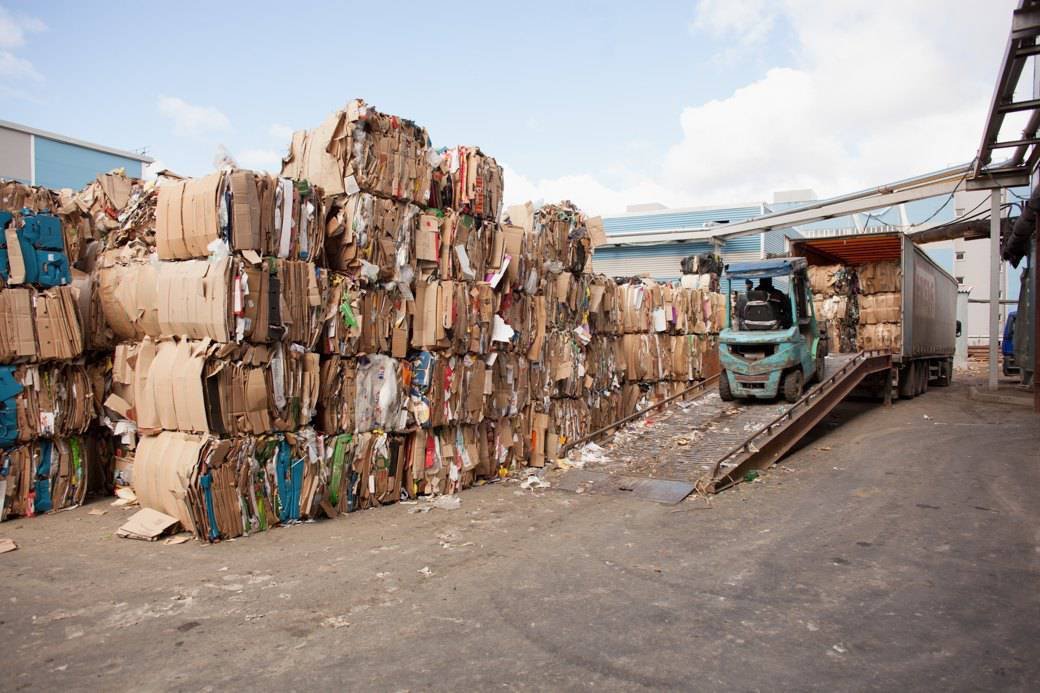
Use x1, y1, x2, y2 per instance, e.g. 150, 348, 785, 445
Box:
719, 257, 827, 403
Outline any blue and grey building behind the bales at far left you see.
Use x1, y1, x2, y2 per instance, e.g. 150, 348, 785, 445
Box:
0, 121, 153, 189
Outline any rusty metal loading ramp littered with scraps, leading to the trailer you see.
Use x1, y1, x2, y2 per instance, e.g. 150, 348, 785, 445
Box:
556, 352, 892, 503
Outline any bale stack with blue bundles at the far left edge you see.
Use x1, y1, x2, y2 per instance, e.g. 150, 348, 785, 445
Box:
0, 182, 101, 519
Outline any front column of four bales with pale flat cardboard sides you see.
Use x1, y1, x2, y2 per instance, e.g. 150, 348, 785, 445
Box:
97, 166, 329, 540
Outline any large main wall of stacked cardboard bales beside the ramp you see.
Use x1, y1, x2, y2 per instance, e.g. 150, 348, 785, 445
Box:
0, 101, 721, 540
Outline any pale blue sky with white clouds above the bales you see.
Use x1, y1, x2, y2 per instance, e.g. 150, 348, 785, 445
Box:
0, 0, 1017, 213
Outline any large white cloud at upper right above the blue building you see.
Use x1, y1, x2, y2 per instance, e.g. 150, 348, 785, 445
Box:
506, 0, 1014, 212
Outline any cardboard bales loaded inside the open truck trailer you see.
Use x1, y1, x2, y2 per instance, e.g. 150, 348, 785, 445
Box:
809, 260, 902, 353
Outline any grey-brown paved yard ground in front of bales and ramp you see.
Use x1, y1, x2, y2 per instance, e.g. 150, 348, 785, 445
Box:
0, 385, 1040, 691
